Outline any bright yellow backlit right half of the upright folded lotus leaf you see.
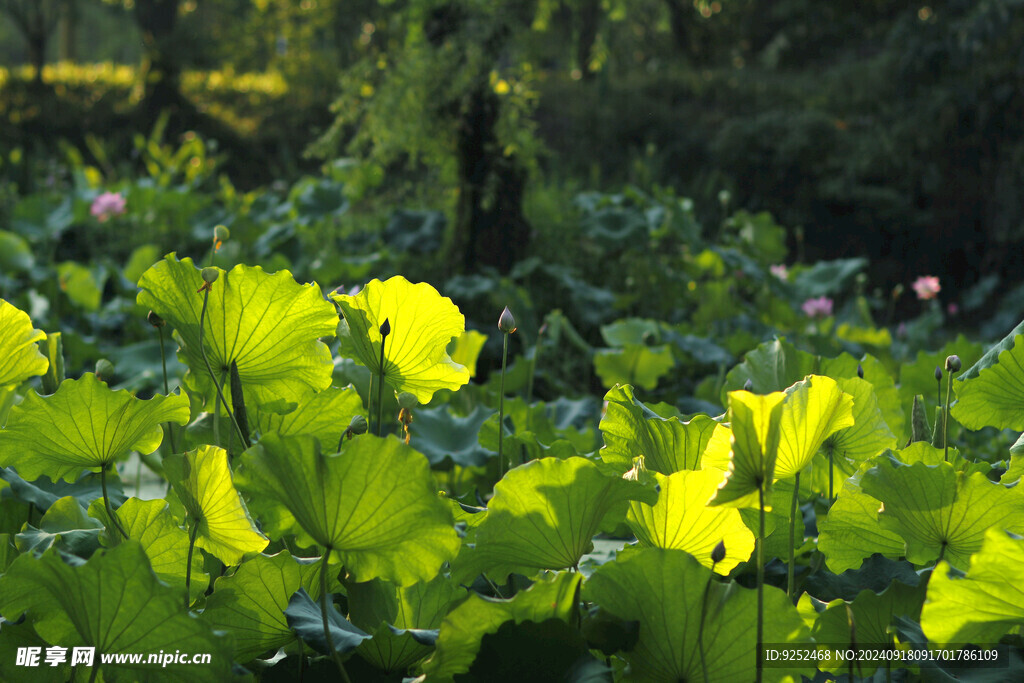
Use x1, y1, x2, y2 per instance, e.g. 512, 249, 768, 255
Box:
774, 375, 854, 479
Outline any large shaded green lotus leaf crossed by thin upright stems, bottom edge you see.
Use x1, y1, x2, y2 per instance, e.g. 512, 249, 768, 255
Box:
583, 548, 813, 683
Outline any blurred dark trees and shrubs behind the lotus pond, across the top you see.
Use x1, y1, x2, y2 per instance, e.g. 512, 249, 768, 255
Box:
0, 0, 1024, 316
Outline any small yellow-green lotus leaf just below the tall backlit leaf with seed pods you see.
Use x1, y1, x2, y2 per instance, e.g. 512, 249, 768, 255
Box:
247, 386, 365, 451
